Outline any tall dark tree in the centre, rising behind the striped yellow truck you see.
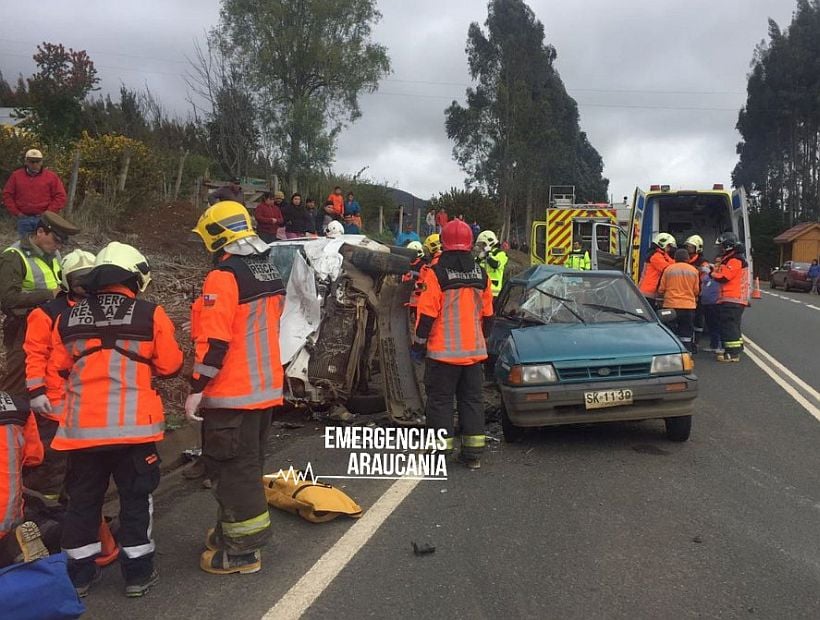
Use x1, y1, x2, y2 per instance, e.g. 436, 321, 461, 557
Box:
446, 0, 609, 240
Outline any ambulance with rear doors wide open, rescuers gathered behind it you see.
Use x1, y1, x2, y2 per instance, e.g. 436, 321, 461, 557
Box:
590, 183, 754, 290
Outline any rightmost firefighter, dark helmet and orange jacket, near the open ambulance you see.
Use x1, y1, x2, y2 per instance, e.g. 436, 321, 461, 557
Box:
712, 232, 749, 362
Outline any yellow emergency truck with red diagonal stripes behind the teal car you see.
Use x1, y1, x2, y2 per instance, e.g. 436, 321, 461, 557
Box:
530, 185, 625, 269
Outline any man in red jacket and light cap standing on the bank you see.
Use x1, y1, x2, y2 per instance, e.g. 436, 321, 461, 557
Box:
3, 149, 66, 239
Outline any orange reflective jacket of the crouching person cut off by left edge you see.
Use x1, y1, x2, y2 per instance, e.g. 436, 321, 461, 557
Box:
0, 392, 43, 538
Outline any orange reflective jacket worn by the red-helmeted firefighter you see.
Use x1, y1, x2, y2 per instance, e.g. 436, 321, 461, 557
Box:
416, 252, 493, 366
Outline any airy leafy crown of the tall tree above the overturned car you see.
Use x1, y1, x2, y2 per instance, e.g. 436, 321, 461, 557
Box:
214, 0, 390, 178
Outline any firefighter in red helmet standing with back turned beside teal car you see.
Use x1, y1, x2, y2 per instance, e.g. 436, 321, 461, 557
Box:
411, 220, 493, 469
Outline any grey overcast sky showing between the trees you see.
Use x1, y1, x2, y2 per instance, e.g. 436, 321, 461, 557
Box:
0, 0, 795, 200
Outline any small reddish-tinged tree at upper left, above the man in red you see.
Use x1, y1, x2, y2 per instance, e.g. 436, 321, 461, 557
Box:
18, 43, 99, 145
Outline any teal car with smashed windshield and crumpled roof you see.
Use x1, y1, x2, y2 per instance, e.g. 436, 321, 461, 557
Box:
488, 265, 698, 441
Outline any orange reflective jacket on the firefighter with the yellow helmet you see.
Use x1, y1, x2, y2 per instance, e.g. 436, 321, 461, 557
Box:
191, 253, 285, 409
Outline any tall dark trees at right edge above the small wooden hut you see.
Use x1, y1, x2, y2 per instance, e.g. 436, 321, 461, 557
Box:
732, 0, 820, 225
